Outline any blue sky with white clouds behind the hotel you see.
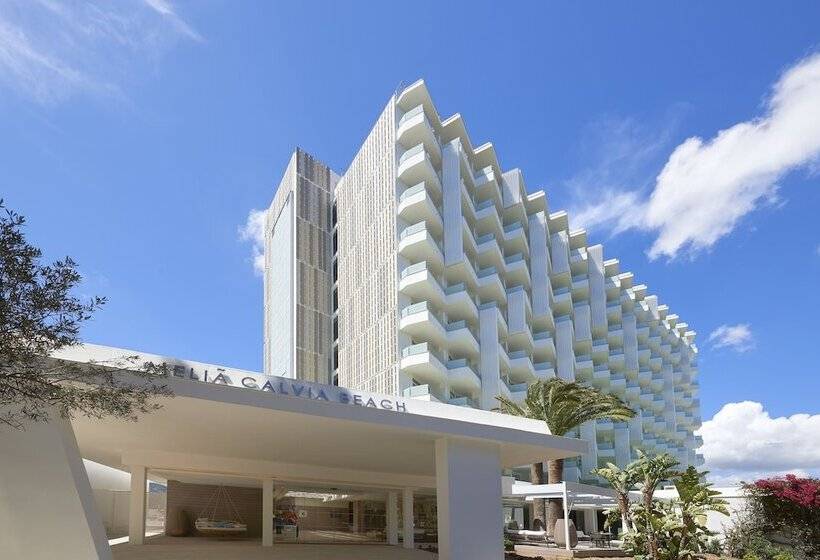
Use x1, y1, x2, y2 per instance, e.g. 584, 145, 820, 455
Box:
0, 0, 820, 482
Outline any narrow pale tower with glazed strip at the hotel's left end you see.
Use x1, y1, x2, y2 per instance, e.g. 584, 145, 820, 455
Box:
264, 148, 339, 383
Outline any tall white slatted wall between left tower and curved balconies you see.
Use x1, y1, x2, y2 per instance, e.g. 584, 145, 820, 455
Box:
336, 98, 398, 394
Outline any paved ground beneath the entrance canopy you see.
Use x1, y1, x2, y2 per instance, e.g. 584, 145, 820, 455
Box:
111, 536, 436, 560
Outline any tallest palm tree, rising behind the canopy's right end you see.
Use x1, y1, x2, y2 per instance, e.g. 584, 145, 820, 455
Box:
496, 378, 635, 534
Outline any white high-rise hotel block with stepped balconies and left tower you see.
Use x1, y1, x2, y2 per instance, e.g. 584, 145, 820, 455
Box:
265, 81, 702, 483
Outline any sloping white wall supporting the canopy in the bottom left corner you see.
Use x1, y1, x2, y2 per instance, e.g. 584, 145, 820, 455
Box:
0, 410, 111, 560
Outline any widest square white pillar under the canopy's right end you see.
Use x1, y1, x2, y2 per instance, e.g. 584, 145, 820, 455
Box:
436, 439, 504, 560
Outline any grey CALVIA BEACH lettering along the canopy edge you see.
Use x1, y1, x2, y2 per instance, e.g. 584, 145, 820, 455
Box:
169, 364, 407, 412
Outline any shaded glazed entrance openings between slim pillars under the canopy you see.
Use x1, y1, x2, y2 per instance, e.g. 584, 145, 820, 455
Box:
161, 470, 438, 549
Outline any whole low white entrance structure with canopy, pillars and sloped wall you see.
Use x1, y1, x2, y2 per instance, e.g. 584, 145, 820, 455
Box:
0, 347, 586, 560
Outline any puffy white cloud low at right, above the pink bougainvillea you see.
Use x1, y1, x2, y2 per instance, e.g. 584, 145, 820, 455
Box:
698, 401, 820, 482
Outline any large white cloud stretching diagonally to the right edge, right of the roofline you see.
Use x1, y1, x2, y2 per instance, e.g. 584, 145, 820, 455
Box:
581, 53, 820, 259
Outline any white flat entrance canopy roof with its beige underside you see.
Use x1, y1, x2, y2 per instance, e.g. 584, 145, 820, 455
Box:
60, 345, 586, 488
